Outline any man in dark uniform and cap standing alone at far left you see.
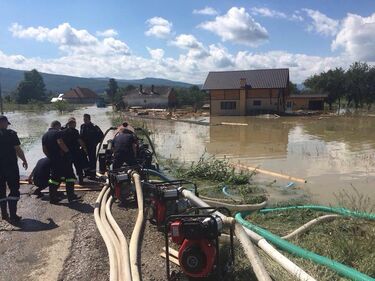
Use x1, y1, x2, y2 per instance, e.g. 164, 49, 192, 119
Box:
0, 115, 27, 223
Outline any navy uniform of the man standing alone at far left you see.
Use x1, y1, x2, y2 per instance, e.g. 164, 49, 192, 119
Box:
0, 129, 20, 219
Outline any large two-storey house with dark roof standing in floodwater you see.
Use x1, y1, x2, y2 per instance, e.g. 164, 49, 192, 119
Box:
202, 68, 289, 115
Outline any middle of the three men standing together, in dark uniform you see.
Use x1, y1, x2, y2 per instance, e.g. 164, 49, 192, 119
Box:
63, 117, 88, 185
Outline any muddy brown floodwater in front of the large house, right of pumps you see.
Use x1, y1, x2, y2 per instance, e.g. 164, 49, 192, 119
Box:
147, 117, 375, 204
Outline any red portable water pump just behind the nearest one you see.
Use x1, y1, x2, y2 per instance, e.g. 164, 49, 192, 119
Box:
143, 180, 197, 229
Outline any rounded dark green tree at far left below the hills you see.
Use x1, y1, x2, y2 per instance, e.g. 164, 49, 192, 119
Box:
13, 69, 46, 103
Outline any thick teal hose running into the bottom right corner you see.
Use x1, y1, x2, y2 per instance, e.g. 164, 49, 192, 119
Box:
236, 212, 375, 281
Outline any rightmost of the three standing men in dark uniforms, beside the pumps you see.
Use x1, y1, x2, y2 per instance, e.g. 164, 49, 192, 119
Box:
80, 113, 104, 176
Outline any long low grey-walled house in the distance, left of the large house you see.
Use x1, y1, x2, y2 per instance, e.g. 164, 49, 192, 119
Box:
123, 85, 176, 108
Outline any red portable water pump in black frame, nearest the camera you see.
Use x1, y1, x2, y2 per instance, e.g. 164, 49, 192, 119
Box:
165, 208, 234, 280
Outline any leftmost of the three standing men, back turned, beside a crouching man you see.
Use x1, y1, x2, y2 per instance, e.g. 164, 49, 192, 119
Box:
42, 121, 80, 204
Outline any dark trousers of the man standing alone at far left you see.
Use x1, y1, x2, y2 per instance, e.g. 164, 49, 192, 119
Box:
0, 166, 20, 217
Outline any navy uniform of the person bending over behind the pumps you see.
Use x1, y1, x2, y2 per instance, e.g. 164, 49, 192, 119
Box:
113, 130, 137, 169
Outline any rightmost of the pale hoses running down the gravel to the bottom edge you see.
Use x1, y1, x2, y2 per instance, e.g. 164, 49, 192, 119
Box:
129, 172, 145, 281
